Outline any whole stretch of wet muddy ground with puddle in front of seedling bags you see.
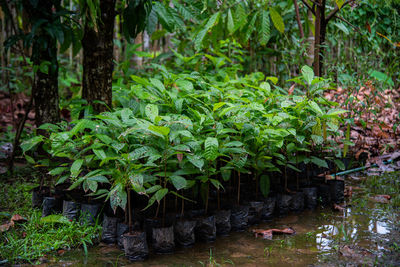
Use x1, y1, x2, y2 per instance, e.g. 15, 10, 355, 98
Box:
51, 176, 400, 266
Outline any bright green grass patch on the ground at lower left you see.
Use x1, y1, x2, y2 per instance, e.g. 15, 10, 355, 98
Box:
0, 178, 101, 264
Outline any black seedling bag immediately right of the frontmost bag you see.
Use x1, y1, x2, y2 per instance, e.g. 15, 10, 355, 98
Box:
152, 226, 175, 254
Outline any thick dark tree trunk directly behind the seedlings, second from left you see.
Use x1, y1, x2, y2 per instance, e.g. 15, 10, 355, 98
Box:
82, 0, 116, 112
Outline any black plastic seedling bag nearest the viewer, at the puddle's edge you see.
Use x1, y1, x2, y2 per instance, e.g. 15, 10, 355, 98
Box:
122, 232, 149, 261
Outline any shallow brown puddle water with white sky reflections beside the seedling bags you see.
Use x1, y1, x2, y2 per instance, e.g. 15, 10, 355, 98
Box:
55, 186, 391, 267
